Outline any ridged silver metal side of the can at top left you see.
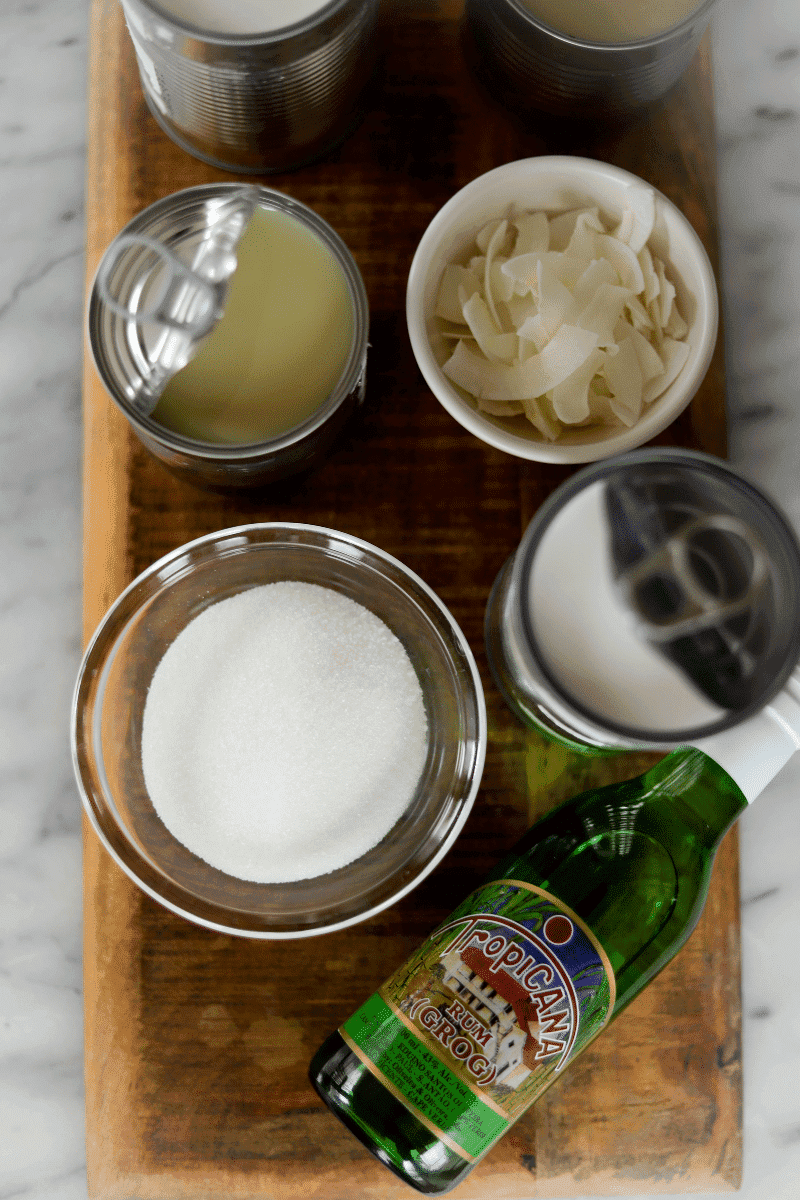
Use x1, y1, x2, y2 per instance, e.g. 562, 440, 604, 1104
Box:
122, 0, 378, 174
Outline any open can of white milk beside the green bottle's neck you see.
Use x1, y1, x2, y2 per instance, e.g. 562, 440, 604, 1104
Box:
486, 448, 800, 752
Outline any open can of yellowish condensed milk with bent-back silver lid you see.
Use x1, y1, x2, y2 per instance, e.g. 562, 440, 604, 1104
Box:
88, 184, 369, 488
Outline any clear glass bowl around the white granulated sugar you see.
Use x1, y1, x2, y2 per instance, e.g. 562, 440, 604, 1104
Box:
72, 523, 486, 938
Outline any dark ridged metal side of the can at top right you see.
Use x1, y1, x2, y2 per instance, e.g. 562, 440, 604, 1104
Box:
464, 0, 714, 121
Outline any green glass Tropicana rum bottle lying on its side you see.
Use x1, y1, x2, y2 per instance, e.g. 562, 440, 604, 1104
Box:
309, 745, 758, 1195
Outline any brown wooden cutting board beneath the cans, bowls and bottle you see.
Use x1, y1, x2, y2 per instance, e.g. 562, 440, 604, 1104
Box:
84, 0, 741, 1200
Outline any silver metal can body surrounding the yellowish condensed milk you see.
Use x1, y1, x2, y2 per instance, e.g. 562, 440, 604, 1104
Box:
86, 184, 369, 488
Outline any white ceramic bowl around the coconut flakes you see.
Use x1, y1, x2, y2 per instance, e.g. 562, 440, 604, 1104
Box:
407, 156, 718, 463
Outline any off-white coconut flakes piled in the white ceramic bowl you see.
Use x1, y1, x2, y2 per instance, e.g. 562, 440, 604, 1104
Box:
435, 186, 690, 442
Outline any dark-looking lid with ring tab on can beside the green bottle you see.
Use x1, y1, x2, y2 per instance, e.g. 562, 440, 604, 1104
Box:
607, 473, 782, 712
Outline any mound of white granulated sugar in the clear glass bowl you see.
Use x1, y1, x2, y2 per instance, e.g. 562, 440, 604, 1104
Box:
142, 581, 427, 883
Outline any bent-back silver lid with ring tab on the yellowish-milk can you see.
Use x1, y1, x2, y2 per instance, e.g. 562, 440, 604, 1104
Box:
95, 186, 259, 416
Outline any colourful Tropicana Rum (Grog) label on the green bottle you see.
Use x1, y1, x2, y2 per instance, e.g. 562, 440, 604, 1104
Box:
339, 880, 615, 1162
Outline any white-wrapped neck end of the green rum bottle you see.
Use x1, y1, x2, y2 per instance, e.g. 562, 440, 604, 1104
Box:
692, 668, 800, 803
